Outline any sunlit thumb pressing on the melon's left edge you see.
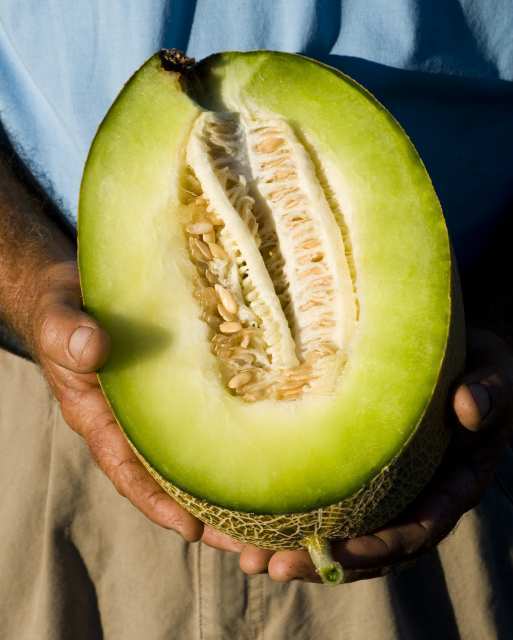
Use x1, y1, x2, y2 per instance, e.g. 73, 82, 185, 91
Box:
36, 302, 110, 373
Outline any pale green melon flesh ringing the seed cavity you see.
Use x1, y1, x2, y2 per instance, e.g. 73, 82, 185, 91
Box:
79, 52, 460, 514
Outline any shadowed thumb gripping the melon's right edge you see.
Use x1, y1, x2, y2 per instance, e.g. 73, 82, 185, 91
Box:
454, 370, 512, 431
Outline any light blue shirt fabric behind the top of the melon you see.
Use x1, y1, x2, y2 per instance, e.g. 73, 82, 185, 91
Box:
0, 0, 513, 262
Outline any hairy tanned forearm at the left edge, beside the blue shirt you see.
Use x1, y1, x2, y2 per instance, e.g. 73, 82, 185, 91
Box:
0, 150, 75, 353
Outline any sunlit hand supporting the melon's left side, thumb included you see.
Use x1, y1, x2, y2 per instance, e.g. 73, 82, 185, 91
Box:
31, 262, 242, 551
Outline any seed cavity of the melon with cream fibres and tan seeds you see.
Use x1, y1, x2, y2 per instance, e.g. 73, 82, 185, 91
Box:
184, 112, 356, 402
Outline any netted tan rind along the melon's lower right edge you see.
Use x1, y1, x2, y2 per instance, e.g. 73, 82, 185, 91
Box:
123, 262, 465, 550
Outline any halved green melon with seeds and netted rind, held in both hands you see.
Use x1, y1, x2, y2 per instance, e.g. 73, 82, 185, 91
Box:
79, 51, 463, 580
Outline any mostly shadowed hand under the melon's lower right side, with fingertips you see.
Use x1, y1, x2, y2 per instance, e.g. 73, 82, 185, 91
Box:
240, 331, 513, 582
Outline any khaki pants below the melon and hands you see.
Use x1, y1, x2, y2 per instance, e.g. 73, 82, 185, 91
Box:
0, 351, 513, 640
